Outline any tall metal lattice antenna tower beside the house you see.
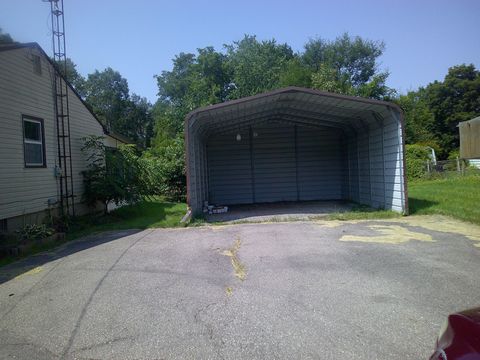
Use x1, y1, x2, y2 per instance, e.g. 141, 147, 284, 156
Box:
43, 0, 75, 216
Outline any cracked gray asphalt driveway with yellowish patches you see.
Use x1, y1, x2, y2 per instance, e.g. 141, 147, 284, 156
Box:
0, 217, 480, 359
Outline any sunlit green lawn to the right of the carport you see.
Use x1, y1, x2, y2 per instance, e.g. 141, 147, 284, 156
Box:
408, 175, 480, 225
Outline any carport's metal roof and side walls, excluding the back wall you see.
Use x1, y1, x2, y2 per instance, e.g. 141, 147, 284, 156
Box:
185, 87, 408, 214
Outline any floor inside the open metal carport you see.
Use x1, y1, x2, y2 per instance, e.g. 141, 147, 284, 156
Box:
206, 200, 352, 223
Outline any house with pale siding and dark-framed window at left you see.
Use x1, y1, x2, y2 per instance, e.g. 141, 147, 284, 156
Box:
0, 43, 125, 231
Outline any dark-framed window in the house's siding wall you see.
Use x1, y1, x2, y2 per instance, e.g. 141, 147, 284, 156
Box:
23, 116, 46, 167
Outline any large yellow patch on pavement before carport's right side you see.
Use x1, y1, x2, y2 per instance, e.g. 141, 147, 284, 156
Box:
340, 225, 435, 244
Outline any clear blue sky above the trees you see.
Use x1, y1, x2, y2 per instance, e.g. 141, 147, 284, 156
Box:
0, 0, 480, 103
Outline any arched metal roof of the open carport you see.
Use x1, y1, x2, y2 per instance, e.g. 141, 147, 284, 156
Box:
185, 86, 403, 139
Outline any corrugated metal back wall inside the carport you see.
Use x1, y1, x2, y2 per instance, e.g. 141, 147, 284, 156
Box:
207, 122, 347, 204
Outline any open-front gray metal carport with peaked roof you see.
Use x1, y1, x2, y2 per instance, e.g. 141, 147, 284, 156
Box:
185, 87, 408, 214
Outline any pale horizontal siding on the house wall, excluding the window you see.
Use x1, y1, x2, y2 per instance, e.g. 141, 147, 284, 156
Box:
0, 48, 103, 219
